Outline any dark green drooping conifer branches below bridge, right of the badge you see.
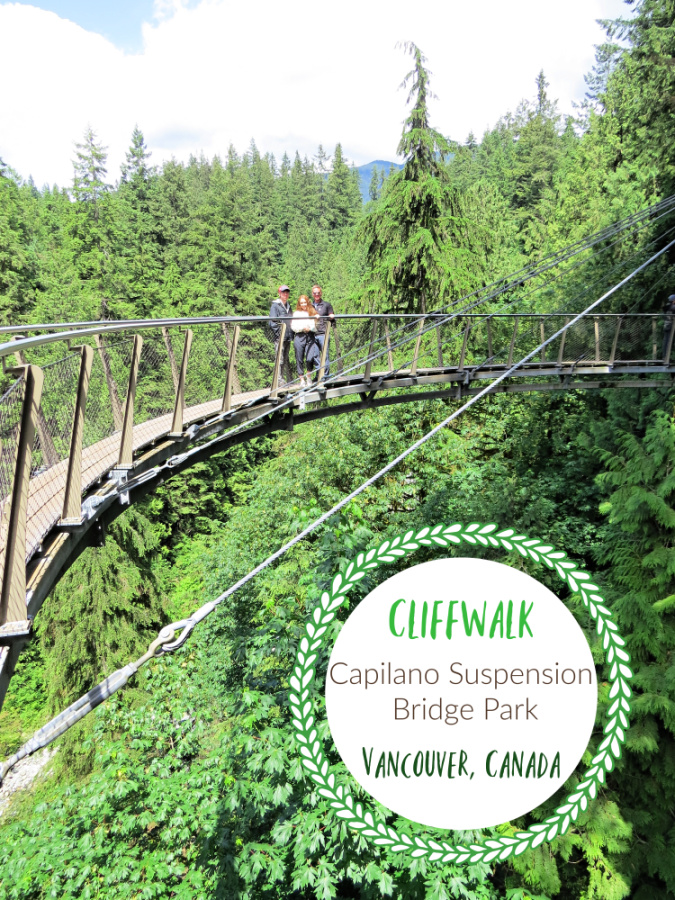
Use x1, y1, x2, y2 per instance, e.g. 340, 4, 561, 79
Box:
597, 411, 675, 900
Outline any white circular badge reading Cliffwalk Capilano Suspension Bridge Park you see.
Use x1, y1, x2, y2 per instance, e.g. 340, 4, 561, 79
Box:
326, 558, 597, 830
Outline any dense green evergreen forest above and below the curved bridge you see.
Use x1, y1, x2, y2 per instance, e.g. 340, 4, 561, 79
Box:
0, 0, 675, 900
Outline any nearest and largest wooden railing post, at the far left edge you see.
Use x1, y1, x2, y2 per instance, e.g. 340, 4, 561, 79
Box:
0, 365, 44, 631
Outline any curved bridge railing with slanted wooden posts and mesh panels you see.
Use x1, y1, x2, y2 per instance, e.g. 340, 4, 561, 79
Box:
0, 313, 673, 638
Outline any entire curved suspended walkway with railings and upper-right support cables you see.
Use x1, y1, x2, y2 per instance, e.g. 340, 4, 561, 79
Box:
0, 199, 675, 780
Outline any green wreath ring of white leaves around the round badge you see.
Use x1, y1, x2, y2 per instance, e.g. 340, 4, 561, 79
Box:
290, 522, 633, 863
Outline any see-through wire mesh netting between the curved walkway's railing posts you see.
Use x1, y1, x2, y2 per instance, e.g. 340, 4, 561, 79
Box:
0, 313, 672, 559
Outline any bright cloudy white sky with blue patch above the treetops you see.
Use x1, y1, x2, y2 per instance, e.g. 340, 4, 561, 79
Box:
0, 0, 629, 187
